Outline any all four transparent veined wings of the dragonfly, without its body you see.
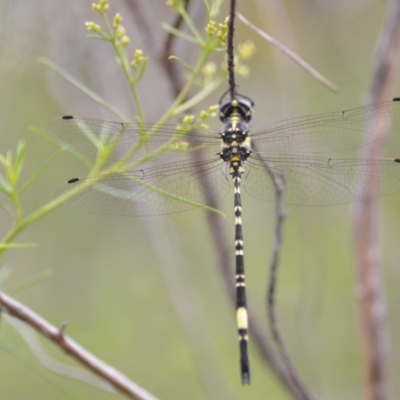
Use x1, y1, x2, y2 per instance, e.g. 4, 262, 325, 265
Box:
47, 101, 400, 215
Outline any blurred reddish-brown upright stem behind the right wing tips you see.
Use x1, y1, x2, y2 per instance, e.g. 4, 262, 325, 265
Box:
355, 0, 400, 400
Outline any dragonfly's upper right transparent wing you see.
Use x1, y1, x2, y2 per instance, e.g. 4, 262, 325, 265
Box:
251, 100, 400, 155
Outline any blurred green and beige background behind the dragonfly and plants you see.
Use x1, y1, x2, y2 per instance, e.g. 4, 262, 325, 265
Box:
0, 0, 400, 400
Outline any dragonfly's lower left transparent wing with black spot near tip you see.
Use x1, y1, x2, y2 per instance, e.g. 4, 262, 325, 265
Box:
56, 157, 231, 216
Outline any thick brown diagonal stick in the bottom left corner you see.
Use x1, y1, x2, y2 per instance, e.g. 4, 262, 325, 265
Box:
0, 292, 157, 400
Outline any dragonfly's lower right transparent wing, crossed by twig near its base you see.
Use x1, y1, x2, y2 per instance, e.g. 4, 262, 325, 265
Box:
242, 155, 400, 206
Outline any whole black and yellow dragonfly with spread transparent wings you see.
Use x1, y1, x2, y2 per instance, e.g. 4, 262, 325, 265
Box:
47, 94, 400, 384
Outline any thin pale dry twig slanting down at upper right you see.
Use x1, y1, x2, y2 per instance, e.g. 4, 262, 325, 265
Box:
236, 12, 337, 93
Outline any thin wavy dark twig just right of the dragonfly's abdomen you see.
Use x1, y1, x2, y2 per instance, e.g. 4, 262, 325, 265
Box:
253, 143, 316, 400
